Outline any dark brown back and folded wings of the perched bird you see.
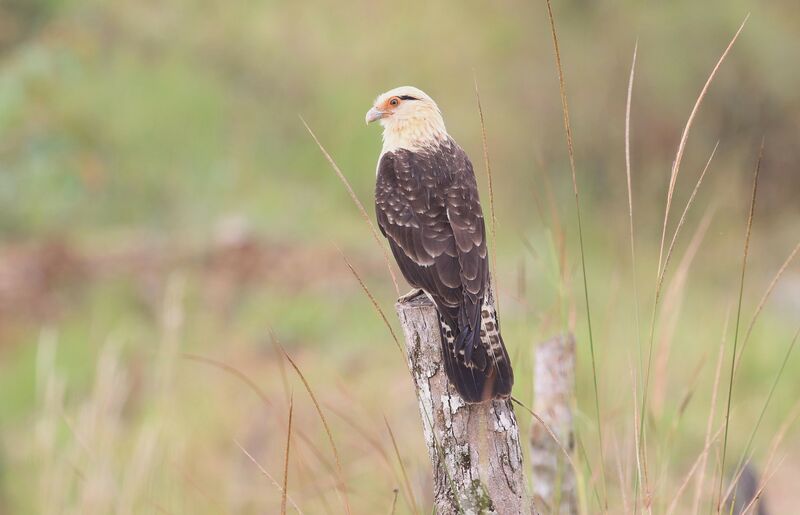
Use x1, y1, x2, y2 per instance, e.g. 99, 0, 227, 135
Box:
375, 144, 488, 328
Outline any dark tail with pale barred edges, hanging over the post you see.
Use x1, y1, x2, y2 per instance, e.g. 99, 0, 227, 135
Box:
439, 302, 514, 403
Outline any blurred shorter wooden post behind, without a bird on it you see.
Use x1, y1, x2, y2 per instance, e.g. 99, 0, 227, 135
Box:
531, 334, 578, 515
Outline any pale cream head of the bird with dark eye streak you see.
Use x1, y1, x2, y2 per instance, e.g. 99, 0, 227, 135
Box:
366, 86, 447, 153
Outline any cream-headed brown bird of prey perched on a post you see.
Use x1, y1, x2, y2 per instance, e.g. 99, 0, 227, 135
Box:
366, 86, 514, 403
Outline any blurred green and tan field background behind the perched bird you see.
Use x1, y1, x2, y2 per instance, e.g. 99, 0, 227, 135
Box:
0, 0, 800, 513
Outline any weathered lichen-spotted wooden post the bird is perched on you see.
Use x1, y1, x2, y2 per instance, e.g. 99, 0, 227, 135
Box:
396, 295, 532, 515
